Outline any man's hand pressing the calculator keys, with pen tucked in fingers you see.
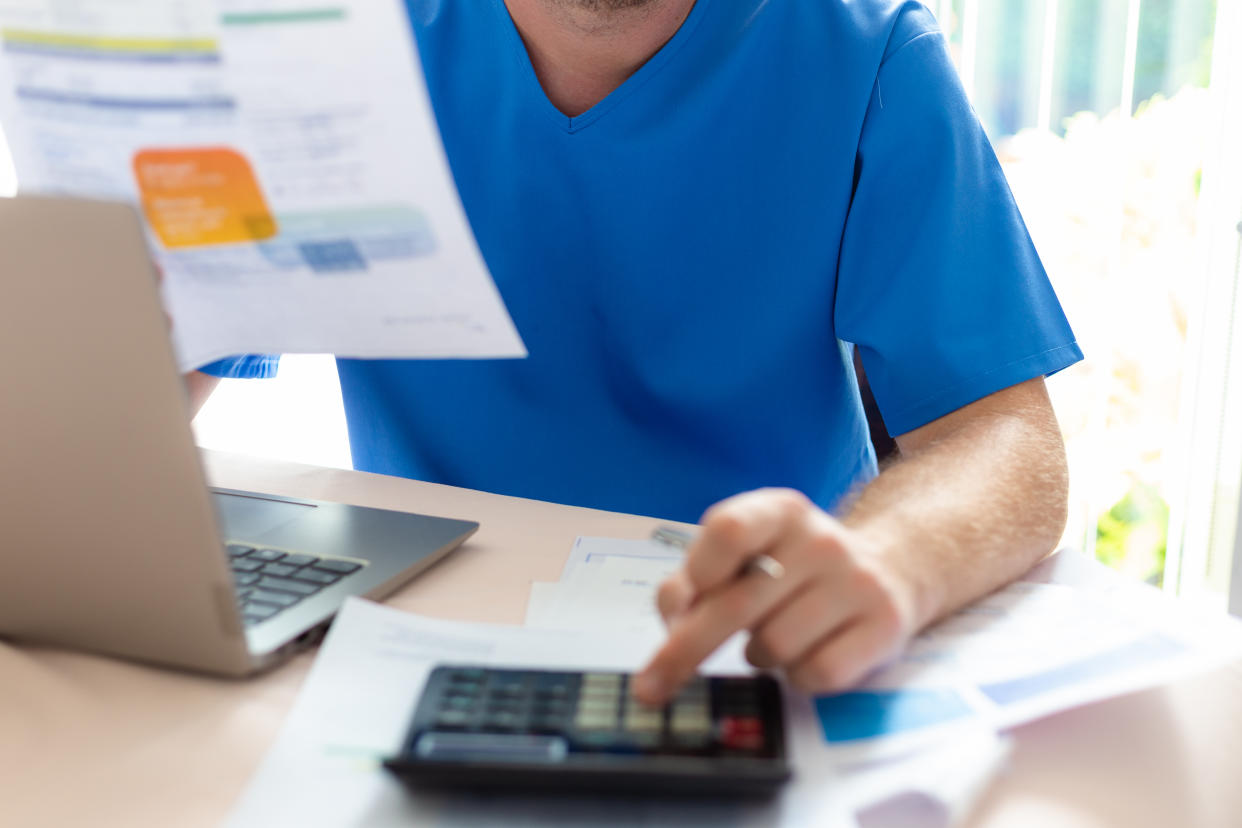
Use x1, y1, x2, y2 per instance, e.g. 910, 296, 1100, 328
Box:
635, 489, 920, 704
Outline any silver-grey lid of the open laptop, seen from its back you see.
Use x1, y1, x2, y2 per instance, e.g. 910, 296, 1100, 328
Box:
0, 197, 251, 674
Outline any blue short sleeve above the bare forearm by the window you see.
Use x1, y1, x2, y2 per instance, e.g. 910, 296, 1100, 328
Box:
833, 12, 1082, 434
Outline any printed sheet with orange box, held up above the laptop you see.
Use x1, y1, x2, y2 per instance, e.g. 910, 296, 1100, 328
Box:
0, 0, 524, 369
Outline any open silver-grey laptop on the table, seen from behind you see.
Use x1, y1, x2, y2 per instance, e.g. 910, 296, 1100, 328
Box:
0, 196, 478, 677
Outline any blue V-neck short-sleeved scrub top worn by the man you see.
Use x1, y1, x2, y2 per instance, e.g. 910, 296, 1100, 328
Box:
203, 0, 1082, 521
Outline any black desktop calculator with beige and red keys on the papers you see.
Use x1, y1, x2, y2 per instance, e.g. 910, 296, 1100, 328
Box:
384, 667, 790, 797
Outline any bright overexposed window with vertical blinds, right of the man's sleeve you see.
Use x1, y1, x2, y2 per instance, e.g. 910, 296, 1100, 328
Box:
935, 0, 1242, 593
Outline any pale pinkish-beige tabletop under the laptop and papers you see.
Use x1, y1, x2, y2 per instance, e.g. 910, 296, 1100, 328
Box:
0, 453, 1242, 828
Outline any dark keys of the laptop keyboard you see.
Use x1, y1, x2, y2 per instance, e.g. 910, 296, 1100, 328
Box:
227, 544, 363, 627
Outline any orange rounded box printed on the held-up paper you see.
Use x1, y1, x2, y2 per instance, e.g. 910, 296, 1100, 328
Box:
134, 148, 276, 248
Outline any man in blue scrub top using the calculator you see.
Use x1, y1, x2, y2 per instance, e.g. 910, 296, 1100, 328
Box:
191, 0, 1081, 703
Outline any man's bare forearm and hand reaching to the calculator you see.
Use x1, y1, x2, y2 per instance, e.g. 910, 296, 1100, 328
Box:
635, 379, 1068, 704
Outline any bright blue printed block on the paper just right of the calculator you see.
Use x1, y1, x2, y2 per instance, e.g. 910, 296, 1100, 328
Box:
815, 689, 974, 742
